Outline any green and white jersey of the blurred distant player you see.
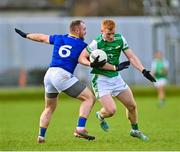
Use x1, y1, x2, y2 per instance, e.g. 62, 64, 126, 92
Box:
151, 59, 169, 79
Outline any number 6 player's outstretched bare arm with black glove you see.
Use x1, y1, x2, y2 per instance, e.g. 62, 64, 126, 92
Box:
15, 28, 49, 44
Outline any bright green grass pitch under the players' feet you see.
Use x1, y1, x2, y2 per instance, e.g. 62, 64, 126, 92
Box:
0, 86, 180, 151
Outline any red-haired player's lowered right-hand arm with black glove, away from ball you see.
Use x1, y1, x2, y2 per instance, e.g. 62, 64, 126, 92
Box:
124, 49, 156, 82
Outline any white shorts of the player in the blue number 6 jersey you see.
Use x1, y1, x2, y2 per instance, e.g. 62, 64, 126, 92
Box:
44, 67, 78, 93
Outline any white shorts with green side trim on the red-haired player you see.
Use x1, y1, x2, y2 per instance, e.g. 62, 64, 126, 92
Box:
92, 75, 129, 98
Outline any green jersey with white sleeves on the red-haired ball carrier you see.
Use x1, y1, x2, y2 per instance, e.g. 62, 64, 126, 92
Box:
87, 34, 129, 77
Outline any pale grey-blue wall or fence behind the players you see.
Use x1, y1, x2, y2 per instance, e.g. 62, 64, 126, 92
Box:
0, 16, 180, 84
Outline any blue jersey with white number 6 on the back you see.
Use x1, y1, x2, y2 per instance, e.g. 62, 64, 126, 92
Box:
49, 34, 87, 73
